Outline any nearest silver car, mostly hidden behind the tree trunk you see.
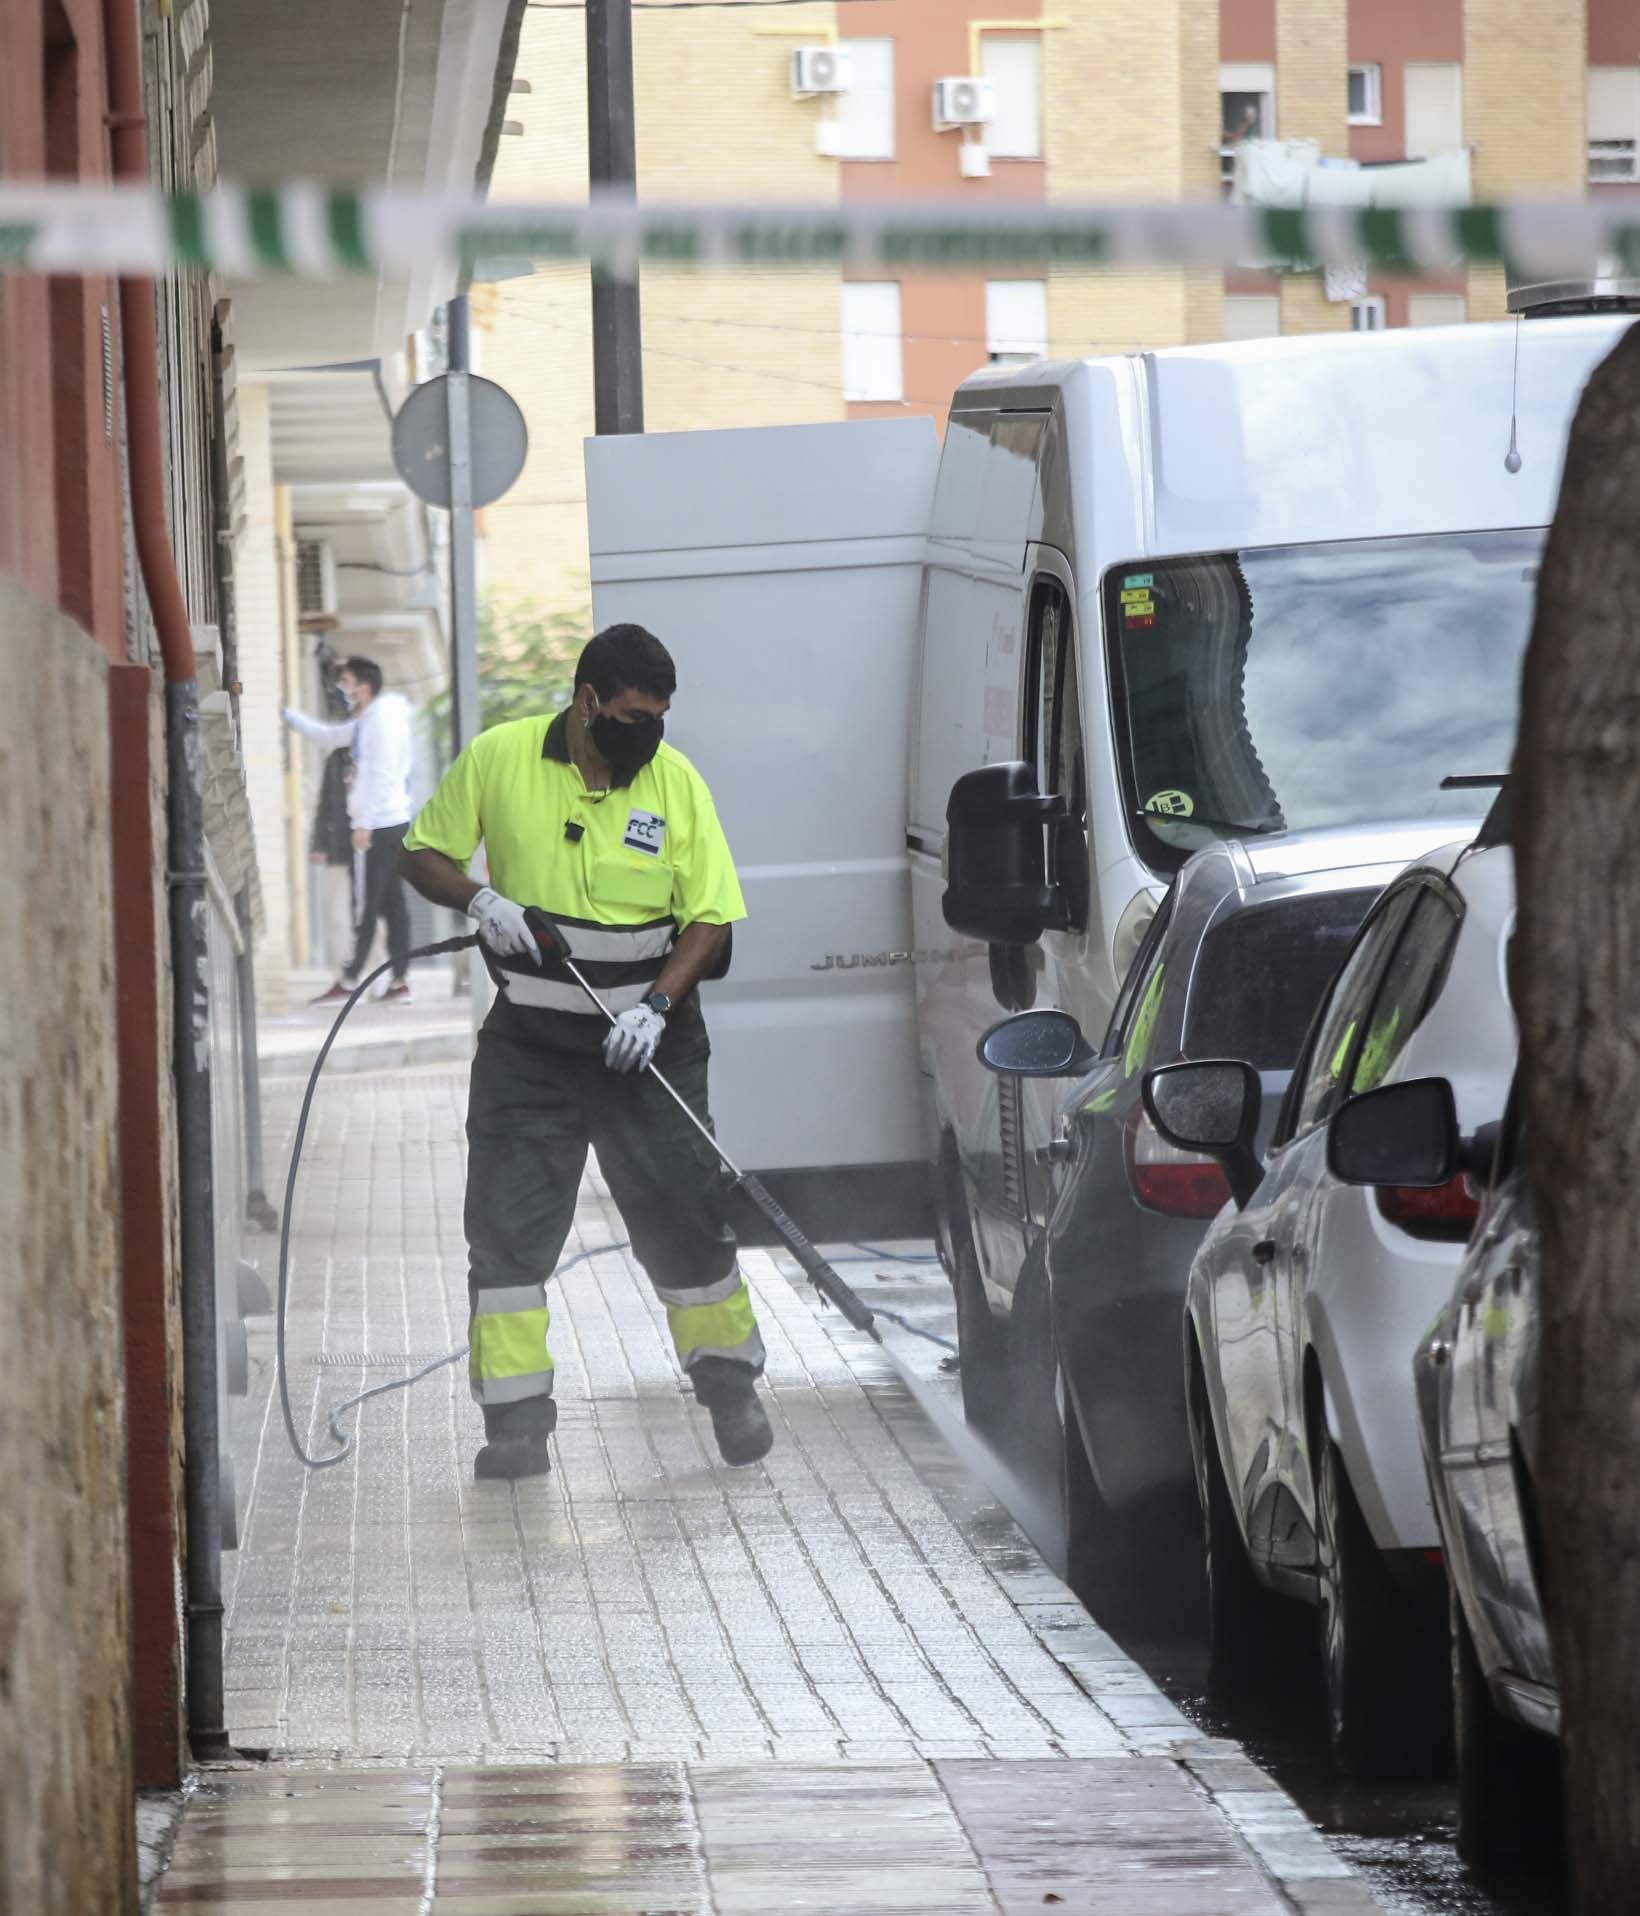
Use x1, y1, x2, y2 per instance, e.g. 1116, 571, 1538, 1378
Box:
1410, 1092, 1563, 1872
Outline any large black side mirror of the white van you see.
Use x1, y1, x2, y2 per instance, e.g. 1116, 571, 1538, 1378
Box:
941, 761, 1065, 945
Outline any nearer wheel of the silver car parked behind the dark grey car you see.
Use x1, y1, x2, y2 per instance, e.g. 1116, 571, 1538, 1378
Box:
1314, 1435, 1448, 1778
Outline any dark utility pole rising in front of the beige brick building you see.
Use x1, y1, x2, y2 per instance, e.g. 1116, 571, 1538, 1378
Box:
586, 0, 644, 433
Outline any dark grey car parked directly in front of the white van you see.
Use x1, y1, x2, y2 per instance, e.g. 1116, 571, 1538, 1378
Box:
958, 824, 1450, 1621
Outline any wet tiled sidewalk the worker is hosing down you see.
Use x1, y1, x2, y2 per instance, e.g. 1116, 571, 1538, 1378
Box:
161, 1071, 1374, 1916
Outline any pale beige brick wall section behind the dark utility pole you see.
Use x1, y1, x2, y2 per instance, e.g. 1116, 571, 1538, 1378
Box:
475, 4, 843, 611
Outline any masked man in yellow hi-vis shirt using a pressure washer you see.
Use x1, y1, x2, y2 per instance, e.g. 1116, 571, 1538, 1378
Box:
402, 625, 774, 1477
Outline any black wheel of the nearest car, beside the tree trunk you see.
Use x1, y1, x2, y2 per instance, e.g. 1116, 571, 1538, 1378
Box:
1450, 1592, 1565, 1876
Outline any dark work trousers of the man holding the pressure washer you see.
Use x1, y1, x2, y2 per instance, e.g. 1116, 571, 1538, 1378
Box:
466, 998, 747, 1441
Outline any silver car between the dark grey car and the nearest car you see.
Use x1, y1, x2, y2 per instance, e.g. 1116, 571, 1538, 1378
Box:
1146, 843, 1515, 1776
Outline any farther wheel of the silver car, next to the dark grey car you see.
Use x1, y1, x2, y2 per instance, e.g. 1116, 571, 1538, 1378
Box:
1190, 1366, 1303, 1701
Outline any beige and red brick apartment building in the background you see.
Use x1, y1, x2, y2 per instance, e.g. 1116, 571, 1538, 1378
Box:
475, 0, 1640, 611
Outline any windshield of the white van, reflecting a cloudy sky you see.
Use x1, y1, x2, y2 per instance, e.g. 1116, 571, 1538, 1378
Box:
1105, 529, 1544, 872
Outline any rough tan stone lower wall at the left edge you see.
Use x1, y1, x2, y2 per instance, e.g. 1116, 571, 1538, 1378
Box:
0, 579, 134, 1916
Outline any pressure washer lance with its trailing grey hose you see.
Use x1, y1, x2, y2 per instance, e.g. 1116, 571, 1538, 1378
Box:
274, 906, 956, 1470
